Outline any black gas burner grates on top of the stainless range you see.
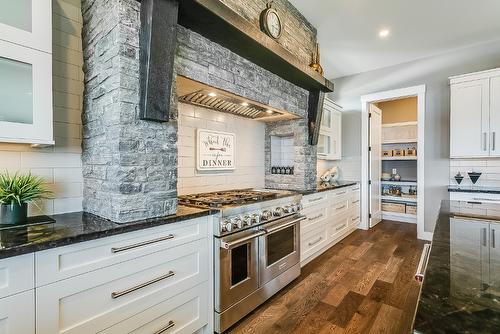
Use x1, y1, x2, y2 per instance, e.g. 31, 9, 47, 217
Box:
179, 189, 278, 208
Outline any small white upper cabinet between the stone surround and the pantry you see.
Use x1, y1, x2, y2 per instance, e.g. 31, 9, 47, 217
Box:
318, 98, 342, 160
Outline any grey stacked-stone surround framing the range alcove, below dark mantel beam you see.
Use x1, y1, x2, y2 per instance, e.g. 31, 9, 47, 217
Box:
82, 0, 316, 222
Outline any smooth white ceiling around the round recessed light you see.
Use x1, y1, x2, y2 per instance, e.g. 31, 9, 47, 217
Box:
290, 0, 500, 78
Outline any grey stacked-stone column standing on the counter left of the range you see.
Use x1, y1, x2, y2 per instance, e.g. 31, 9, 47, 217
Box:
82, 0, 177, 222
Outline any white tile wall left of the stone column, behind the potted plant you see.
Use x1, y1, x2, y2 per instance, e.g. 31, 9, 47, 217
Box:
0, 0, 83, 214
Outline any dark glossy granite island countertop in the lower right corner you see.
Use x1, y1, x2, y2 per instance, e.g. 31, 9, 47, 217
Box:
414, 201, 500, 333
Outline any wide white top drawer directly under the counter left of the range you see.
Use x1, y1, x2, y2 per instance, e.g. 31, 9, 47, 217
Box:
35, 217, 209, 286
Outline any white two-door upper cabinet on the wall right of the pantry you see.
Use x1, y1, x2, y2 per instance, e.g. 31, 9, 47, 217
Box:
450, 70, 500, 158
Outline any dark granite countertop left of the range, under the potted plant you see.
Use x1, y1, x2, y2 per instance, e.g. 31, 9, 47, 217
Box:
0, 205, 217, 259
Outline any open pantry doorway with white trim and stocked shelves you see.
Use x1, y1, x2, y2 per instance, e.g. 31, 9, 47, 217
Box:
361, 85, 431, 240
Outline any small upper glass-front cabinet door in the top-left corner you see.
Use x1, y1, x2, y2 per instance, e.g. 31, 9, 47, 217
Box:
0, 0, 52, 53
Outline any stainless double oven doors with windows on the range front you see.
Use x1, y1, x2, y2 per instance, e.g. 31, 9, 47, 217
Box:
215, 215, 304, 312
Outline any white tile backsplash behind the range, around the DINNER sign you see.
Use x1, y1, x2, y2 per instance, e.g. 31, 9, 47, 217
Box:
177, 103, 265, 195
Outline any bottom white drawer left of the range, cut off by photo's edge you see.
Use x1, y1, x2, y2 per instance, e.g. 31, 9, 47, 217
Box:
99, 283, 208, 334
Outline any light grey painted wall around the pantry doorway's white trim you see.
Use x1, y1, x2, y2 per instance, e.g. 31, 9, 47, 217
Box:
332, 41, 500, 231
